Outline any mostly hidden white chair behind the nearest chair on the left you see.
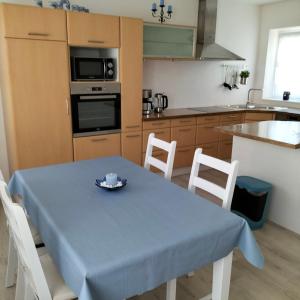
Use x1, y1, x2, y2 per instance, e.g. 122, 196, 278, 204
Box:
0, 170, 43, 288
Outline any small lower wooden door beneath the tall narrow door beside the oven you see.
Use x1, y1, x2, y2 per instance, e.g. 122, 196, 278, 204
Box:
121, 131, 143, 165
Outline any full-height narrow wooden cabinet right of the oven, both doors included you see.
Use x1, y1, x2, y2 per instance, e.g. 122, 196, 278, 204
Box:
120, 17, 143, 164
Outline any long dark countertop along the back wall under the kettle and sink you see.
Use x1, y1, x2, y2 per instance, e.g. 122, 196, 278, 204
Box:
143, 105, 300, 121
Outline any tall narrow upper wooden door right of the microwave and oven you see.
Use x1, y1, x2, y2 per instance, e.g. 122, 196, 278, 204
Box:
120, 17, 143, 132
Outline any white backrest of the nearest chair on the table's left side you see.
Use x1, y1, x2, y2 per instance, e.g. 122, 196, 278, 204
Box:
0, 182, 52, 300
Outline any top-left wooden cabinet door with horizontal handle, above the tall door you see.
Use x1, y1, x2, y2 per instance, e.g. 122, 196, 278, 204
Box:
0, 3, 67, 41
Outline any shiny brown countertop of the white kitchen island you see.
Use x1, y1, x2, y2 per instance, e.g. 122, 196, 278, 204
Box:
217, 121, 300, 149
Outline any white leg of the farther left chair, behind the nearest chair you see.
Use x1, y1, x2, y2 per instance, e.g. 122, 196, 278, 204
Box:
5, 235, 18, 287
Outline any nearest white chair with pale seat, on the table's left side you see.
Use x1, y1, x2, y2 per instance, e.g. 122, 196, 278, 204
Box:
0, 182, 76, 300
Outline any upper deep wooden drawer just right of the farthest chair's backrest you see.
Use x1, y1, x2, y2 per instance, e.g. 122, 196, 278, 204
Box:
171, 126, 196, 147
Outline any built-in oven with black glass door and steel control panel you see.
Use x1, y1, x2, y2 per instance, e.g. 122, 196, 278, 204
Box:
71, 82, 121, 136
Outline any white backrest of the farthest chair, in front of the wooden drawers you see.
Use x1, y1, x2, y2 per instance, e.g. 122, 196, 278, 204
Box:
144, 133, 176, 180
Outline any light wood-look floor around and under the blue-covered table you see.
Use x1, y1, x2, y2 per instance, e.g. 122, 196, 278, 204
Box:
0, 171, 300, 300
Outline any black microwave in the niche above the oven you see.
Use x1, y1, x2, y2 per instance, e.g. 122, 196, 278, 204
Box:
71, 56, 116, 81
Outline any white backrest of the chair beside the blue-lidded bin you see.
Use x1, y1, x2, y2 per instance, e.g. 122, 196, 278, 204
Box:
188, 148, 239, 210
